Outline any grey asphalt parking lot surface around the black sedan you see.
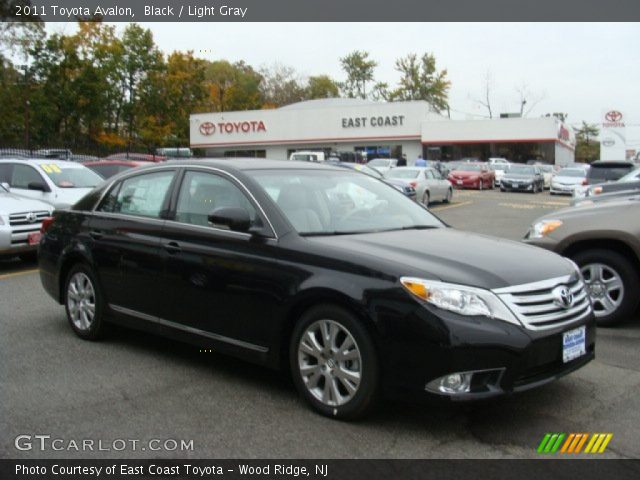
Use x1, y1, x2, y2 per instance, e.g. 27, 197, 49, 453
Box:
0, 191, 640, 458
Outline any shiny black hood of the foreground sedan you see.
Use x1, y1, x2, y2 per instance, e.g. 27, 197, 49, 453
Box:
305, 228, 575, 289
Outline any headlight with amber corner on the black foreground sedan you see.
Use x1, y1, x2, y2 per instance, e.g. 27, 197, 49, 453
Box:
400, 277, 519, 325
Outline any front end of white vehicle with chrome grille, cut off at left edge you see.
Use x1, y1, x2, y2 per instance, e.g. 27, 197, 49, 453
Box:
0, 185, 53, 257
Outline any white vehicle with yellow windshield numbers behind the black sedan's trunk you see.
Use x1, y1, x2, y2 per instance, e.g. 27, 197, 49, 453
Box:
0, 159, 103, 209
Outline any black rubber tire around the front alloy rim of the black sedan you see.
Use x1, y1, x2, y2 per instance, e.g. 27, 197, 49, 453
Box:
289, 304, 379, 420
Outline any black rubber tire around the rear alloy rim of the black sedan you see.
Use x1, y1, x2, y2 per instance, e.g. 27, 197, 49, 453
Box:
64, 263, 106, 340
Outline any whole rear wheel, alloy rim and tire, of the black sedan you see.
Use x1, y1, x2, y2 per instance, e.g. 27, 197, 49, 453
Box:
65, 264, 104, 340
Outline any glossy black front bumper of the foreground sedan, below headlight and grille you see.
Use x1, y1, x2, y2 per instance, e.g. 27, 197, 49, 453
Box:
382, 305, 596, 401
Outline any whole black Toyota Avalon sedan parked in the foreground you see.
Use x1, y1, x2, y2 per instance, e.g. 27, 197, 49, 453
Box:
39, 159, 595, 419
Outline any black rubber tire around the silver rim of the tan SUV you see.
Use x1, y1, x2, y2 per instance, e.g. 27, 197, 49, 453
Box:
572, 249, 640, 327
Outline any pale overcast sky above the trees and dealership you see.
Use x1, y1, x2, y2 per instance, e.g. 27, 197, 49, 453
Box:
48, 22, 640, 146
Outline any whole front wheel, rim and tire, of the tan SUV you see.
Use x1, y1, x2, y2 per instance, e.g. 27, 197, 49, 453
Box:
573, 249, 640, 326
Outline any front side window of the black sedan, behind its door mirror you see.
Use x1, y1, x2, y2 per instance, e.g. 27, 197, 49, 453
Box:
175, 171, 256, 226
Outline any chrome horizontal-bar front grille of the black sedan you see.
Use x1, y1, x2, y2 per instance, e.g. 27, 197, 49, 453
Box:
494, 275, 591, 330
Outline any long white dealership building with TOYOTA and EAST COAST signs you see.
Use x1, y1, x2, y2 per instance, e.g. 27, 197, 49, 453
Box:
190, 98, 575, 165
